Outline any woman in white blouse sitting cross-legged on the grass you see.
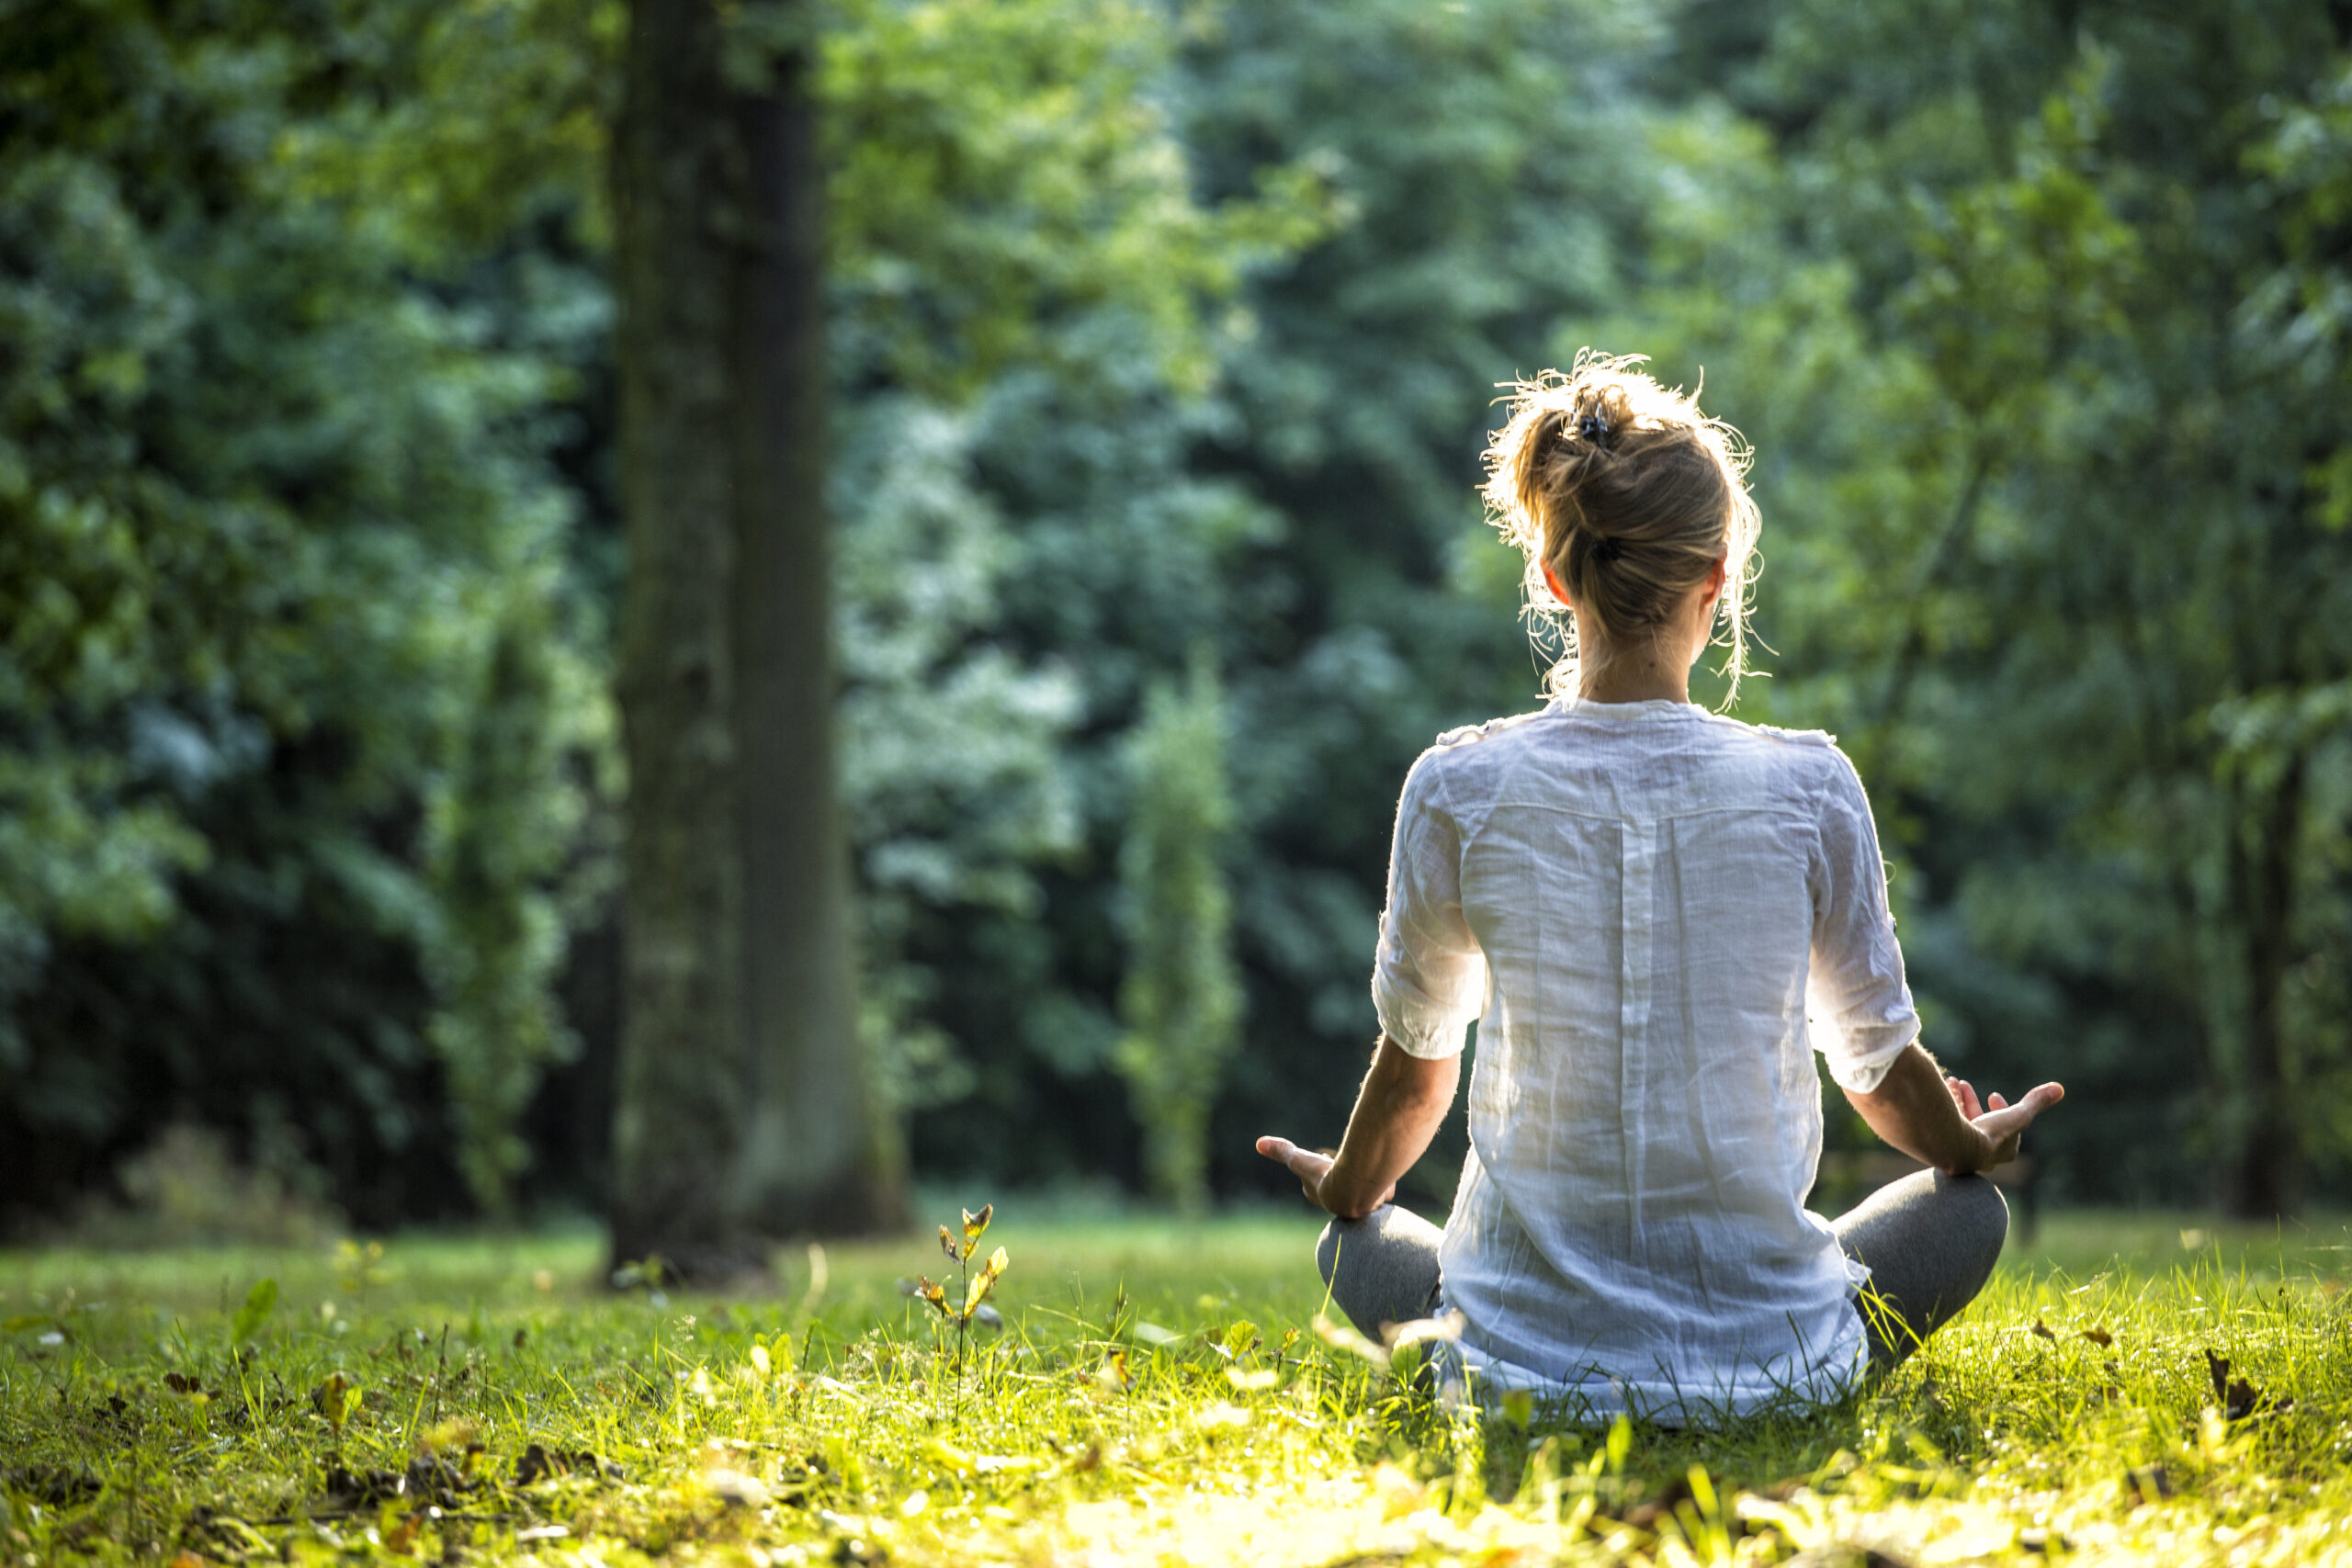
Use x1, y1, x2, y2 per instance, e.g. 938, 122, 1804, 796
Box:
1259, 357, 2065, 1422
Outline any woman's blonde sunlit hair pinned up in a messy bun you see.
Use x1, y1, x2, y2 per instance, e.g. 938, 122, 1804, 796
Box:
1487, 348, 1759, 707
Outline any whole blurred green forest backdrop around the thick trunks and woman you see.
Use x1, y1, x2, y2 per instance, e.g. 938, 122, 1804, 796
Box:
0, 0, 2352, 1227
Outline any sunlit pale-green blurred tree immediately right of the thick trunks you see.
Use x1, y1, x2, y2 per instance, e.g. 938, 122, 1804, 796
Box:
826, 0, 1327, 1180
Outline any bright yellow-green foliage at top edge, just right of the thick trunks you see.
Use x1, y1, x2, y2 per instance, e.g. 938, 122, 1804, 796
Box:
823, 0, 1315, 402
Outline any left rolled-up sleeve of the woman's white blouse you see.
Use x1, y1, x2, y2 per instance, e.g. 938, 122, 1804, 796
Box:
1371, 750, 1487, 1058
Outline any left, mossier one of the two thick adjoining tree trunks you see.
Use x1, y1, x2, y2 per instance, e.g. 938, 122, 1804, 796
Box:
612, 0, 751, 1274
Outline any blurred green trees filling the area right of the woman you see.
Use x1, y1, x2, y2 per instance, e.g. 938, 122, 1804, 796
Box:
1644, 0, 2352, 1215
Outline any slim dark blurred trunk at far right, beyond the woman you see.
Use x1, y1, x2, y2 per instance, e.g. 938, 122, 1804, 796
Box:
2222, 750, 2305, 1220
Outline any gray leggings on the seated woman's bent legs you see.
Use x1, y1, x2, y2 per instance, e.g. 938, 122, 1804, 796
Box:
1315, 1170, 2008, 1371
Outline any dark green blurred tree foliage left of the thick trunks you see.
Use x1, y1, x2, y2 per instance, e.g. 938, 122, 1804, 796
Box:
0, 0, 605, 1223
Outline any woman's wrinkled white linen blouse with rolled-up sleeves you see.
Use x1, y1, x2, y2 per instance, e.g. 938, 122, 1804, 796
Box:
1371, 698, 1919, 1420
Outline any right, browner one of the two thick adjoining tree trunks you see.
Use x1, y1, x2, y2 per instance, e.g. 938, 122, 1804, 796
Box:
731, 12, 906, 1235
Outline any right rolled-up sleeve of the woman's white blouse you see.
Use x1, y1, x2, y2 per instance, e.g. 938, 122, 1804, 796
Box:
1806, 748, 1919, 1093
